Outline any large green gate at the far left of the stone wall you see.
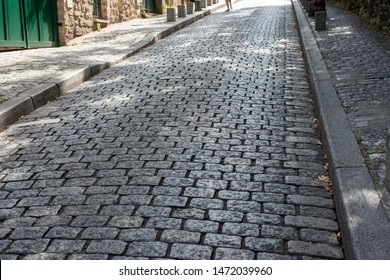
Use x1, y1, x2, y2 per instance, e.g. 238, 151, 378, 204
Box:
0, 0, 58, 48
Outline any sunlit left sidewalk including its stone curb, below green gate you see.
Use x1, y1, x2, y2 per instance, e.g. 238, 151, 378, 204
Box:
0, 1, 225, 131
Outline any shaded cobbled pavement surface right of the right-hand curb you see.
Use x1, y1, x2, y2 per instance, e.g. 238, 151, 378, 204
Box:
304, 3, 390, 212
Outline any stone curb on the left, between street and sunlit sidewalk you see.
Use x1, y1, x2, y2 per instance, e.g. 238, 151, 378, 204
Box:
0, 3, 225, 132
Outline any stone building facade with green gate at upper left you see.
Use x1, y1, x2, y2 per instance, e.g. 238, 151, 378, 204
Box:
0, 0, 142, 49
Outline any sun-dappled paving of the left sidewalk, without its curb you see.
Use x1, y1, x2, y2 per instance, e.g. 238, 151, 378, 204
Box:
0, 2, 223, 103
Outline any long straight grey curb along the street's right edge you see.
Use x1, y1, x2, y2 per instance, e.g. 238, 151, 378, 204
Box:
291, 0, 390, 260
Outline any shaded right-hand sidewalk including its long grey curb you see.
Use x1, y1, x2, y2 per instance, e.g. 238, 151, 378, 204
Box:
292, 0, 390, 259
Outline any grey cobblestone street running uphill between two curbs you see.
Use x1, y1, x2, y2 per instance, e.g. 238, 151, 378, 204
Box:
0, 0, 344, 260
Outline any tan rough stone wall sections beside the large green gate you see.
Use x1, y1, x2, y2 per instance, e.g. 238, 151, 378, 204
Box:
57, 0, 142, 45
